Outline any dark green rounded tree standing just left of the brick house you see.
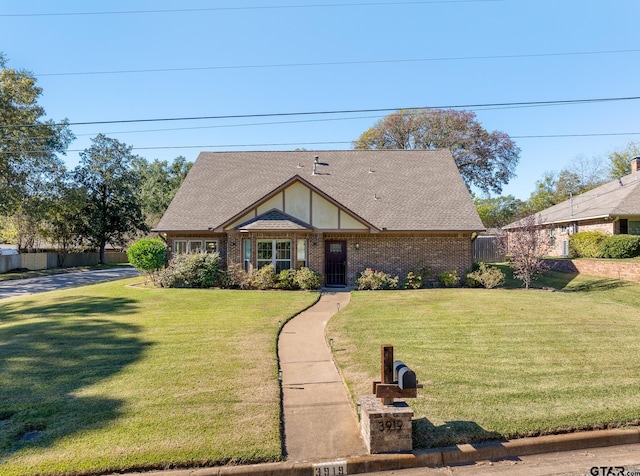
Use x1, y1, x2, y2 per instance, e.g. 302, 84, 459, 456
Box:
74, 134, 148, 263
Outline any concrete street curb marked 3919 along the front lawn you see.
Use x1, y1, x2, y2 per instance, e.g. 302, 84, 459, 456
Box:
124, 428, 640, 476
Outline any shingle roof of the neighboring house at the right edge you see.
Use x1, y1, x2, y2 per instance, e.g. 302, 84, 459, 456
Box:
504, 173, 640, 229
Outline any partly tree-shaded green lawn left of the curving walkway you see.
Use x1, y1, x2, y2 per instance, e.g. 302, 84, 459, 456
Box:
0, 278, 317, 475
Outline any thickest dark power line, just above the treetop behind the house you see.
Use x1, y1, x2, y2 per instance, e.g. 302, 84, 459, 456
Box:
5, 96, 640, 130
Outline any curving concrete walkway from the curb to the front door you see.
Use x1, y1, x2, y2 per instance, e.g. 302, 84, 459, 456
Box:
278, 291, 367, 461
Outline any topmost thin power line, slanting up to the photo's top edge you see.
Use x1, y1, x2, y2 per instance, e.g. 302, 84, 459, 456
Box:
0, 0, 503, 17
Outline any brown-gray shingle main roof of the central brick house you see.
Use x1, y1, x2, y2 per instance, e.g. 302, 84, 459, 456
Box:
156, 150, 484, 231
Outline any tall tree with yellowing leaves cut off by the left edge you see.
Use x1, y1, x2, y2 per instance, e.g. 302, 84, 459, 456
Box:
0, 53, 74, 214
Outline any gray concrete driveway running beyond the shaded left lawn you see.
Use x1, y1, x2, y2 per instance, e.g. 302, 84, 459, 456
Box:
0, 266, 139, 299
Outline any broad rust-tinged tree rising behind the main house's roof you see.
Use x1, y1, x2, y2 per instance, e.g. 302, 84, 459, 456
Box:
353, 109, 520, 194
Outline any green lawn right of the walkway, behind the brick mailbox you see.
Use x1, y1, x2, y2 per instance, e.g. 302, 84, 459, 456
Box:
327, 273, 640, 448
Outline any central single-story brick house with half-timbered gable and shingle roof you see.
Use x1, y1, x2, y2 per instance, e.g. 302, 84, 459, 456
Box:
155, 150, 484, 286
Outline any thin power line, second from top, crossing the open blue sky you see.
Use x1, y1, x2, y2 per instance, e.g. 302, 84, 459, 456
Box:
35, 49, 640, 77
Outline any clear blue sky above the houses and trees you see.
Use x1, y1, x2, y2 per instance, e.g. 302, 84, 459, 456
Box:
0, 0, 640, 199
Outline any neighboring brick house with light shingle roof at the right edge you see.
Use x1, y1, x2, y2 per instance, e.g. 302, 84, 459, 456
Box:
504, 157, 640, 256
